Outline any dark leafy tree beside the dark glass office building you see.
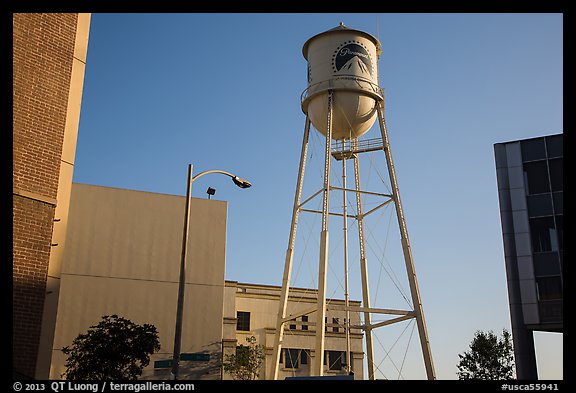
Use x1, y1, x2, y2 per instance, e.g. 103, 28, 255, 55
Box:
458, 329, 514, 380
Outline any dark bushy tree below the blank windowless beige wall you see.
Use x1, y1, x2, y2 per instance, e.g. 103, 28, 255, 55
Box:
62, 315, 160, 380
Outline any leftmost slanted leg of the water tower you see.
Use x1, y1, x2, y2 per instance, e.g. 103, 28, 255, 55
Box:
267, 116, 310, 379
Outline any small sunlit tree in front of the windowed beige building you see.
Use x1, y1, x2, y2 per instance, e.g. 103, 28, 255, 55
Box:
223, 336, 266, 380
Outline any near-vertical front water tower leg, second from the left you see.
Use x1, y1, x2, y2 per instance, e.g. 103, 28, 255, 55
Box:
310, 90, 334, 376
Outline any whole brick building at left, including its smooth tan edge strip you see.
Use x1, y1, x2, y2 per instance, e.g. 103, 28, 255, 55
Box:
12, 13, 90, 378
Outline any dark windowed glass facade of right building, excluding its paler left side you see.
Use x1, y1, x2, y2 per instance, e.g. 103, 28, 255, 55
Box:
520, 135, 564, 323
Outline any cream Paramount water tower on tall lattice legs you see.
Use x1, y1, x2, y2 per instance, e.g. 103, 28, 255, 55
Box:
268, 23, 435, 379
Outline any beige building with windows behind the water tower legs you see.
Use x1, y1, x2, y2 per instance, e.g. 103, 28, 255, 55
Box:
222, 281, 364, 379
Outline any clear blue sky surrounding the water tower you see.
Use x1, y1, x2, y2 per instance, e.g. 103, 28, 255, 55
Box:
74, 13, 563, 379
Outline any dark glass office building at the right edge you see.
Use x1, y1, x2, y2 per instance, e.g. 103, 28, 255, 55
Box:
494, 134, 564, 379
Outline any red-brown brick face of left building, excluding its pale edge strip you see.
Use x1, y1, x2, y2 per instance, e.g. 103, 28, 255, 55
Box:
12, 14, 77, 377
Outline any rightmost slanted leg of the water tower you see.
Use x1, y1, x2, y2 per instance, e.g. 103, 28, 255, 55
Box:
376, 102, 436, 379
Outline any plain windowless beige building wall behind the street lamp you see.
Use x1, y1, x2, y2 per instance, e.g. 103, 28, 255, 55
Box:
50, 184, 227, 379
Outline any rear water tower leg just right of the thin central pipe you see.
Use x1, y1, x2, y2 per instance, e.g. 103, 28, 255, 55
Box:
354, 139, 376, 379
